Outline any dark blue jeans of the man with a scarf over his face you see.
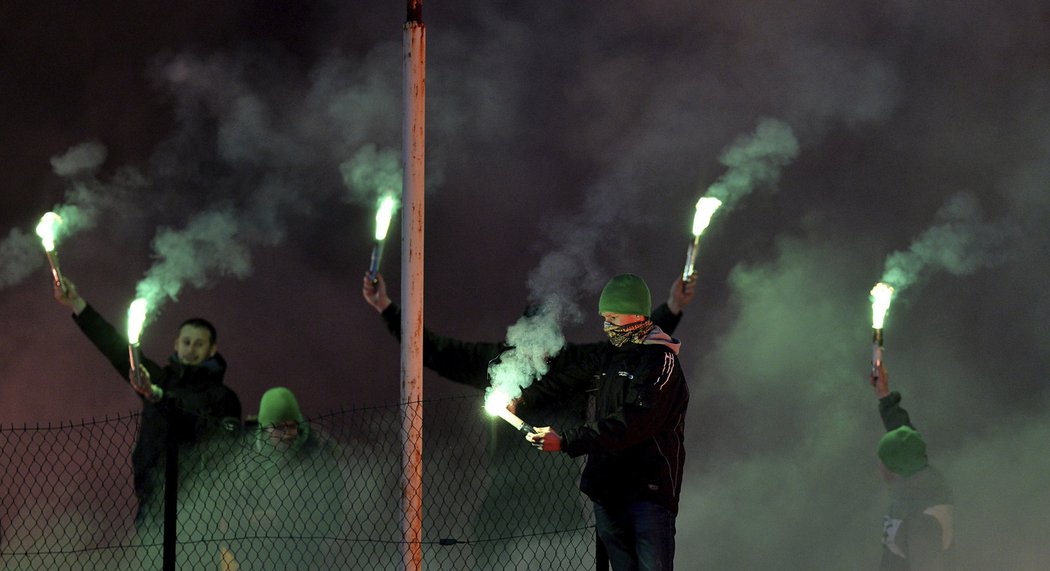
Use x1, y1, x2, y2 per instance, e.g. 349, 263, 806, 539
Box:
594, 502, 674, 571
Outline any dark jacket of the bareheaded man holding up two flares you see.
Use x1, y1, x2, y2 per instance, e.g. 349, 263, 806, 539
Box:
74, 305, 240, 504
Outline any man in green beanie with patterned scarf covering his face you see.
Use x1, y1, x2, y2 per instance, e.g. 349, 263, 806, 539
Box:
513, 274, 689, 571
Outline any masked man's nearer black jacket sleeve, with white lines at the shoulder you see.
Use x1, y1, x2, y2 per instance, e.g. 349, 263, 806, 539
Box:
562, 351, 689, 457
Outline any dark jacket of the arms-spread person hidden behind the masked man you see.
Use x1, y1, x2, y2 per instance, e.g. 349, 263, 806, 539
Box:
381, 303, 681, 389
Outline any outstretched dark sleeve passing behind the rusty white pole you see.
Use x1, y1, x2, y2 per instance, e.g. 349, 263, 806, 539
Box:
381, 303, 508, 389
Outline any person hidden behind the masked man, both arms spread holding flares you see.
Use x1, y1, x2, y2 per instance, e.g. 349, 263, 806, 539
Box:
361, 274, 696, 389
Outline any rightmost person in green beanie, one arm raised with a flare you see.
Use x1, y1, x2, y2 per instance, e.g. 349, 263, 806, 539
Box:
872, 364, 954, 571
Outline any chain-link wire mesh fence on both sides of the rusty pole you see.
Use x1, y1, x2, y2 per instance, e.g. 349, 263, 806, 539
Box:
0, 397, 595, 571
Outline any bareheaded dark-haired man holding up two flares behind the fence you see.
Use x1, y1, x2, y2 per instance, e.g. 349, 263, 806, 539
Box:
55, 278, 240, 517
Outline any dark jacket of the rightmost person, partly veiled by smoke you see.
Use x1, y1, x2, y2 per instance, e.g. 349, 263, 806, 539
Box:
879, 390, 954, 571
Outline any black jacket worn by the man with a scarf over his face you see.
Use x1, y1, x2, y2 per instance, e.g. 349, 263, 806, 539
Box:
519, 329, 689, 513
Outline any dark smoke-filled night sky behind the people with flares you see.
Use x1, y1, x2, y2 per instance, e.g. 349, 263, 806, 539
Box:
0, 0, 1050, 569
